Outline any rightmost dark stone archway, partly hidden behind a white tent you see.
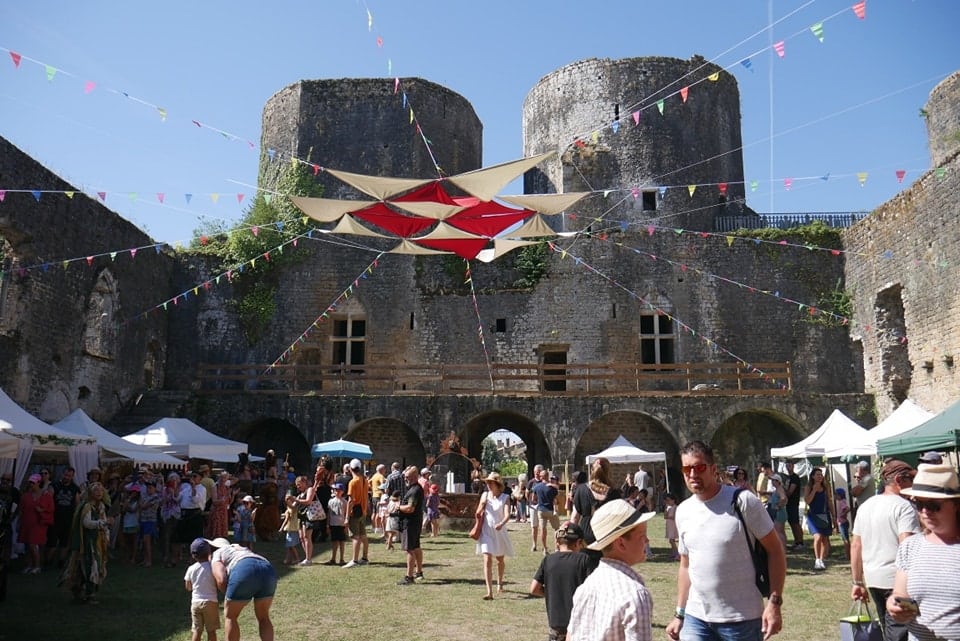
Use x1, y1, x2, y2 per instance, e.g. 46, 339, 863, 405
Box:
710, 409, 806, 478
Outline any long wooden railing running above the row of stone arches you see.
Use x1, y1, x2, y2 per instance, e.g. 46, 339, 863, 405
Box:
196, 362, 792, 396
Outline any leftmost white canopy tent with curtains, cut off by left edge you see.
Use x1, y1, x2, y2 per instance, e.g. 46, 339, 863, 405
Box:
0, 390, 96, 486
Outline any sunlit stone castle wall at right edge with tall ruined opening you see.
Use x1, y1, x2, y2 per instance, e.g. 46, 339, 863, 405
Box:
845, 73, 960, 417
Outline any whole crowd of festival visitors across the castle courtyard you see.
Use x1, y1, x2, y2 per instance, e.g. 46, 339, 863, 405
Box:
0, 441, 960, 641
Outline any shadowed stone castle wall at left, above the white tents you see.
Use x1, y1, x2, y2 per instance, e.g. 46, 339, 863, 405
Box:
0, 138, 175, 420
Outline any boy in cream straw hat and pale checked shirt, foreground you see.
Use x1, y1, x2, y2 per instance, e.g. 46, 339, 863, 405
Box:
567, 499, 656, 641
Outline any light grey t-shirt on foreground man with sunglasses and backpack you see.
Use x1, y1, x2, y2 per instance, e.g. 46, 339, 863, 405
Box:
677, 485, 773, 623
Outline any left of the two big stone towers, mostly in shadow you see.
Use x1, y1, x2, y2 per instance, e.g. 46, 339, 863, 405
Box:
260, 78, 483, 192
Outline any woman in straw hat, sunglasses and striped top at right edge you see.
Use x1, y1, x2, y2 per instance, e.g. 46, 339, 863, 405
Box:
887, 464, 960, 641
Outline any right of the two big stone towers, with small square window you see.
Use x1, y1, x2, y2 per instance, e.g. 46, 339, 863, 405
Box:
523, 56, 749, 231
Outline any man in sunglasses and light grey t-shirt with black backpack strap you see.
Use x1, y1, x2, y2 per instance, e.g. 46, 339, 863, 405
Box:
667, 441, 787, 641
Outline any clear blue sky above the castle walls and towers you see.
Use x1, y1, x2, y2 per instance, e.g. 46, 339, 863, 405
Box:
0, 0, 960, 246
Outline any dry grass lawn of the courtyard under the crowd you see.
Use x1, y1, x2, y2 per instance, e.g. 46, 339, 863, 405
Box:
0, 516, 850, 641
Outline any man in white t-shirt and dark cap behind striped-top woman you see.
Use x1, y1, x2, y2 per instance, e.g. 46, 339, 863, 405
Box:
850, 459, 920, 641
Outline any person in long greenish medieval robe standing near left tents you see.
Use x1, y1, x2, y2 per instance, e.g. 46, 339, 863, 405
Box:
60, 483, 112, 603
